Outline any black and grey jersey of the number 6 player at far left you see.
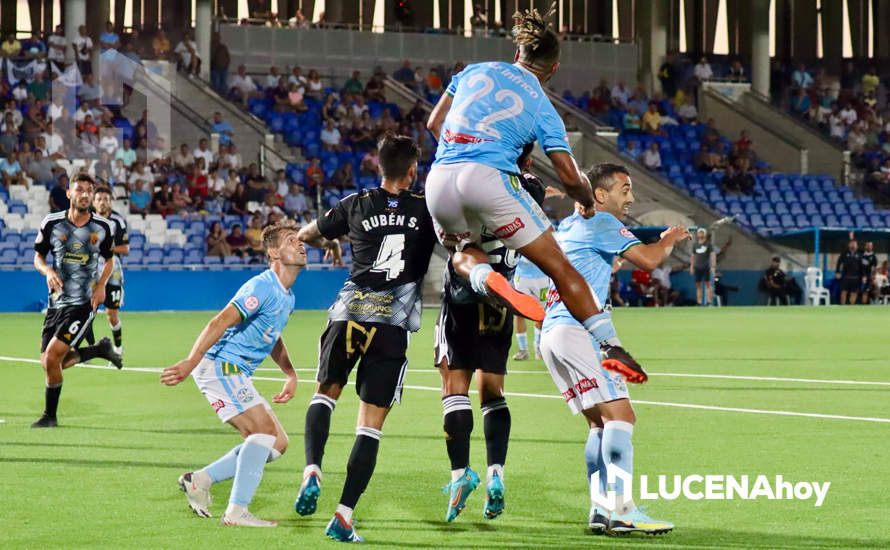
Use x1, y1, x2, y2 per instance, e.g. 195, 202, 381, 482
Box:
34, 211, 114, 308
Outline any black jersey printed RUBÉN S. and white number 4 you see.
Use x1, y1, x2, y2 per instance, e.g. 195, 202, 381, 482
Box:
318, 187, 436, 331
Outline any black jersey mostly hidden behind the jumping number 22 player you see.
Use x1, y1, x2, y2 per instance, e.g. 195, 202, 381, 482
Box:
442, 172, 545, 304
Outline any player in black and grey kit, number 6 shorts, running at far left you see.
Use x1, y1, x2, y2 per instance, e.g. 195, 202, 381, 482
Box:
31, 175, 121, 428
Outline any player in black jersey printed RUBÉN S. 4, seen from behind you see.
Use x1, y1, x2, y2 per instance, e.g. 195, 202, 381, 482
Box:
294, 135, 436, 542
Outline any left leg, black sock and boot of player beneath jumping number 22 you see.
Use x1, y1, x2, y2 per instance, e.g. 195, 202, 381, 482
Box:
438, 364, 479, 522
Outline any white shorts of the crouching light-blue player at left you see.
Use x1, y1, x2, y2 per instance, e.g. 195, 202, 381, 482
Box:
192, 357, 272, 422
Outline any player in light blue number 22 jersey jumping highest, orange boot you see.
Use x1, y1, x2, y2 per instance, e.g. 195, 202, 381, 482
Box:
426, 9, 602, 338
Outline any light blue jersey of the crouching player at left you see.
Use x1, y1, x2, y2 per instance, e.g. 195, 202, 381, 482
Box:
206, 269, 294, 376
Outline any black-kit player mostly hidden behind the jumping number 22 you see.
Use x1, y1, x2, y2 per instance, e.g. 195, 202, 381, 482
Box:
435, 143, 546, 522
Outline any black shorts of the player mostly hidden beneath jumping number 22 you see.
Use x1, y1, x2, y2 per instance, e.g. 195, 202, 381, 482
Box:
435, 302, 513, 374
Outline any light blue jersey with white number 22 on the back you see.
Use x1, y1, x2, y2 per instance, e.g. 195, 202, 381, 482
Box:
433, 62, 571, 174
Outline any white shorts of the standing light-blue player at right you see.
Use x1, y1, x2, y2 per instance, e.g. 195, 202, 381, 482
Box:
541, 325, 629, 414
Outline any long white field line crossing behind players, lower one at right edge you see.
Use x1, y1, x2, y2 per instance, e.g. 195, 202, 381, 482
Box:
0, 356, 890, 424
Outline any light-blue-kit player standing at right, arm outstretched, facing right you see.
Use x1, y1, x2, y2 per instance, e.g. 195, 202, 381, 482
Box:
541, 164, 689, 534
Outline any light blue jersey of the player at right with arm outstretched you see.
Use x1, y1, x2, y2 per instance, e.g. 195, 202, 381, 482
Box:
543, 212, 640, 332
